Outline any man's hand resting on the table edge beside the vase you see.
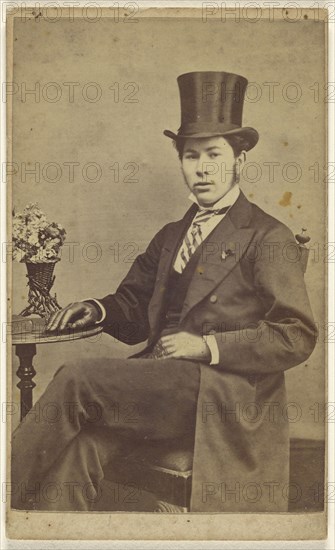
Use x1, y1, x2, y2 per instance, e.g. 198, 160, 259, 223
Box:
45, 302, 99, 332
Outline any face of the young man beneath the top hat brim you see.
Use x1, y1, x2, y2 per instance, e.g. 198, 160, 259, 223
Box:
181, 136, 238, 206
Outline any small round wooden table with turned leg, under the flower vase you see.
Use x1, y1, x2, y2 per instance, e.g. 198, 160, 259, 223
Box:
12, 315, 103, 420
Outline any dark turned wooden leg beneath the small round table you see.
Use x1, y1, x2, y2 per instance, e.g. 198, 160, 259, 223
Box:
16, 344, 36, 420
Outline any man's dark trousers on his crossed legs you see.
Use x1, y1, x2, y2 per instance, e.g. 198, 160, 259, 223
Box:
12, 358, 200, 511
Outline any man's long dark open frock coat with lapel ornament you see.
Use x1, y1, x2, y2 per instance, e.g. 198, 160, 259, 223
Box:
100, 193, 316, 512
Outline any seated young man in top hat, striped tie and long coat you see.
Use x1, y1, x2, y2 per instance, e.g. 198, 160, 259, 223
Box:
12, 72, 315, 512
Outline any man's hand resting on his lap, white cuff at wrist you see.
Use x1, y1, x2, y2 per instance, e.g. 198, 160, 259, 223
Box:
159, 332, 211, 362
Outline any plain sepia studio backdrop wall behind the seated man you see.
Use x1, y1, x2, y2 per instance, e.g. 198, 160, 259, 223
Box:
12, 11, 327, 448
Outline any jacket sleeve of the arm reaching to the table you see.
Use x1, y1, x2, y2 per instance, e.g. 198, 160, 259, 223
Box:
97, 226, 166, 344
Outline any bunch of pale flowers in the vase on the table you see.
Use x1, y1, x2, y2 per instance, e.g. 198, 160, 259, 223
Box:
13, 203, 66, 264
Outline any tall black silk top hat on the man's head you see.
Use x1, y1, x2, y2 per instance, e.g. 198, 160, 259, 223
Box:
164, 71, 259, 151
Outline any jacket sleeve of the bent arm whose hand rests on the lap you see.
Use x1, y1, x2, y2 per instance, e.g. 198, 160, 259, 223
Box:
215, 225, 317, 374
